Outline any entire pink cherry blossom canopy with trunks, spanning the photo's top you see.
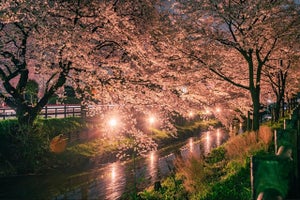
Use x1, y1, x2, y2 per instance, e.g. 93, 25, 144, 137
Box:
0, 0, 299, 129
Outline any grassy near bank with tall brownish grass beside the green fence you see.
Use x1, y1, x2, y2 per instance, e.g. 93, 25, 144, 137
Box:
140, 126, 273, 200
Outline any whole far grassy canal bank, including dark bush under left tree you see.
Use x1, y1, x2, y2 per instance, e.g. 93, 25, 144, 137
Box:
0, 118, 220, 177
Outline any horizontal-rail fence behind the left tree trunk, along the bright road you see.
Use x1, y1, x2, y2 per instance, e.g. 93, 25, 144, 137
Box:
0, 105, 84, 120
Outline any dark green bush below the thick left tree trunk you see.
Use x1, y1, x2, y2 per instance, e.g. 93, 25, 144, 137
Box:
0, 120, 49, 175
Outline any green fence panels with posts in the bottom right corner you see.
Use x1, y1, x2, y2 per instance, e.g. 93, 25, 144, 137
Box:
251, 106, 300, 200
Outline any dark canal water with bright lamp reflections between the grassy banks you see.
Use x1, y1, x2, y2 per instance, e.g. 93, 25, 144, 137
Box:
0, 129, 228, 200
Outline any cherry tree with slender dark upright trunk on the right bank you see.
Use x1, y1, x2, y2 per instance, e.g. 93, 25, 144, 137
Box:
174, 0, 299, 130
